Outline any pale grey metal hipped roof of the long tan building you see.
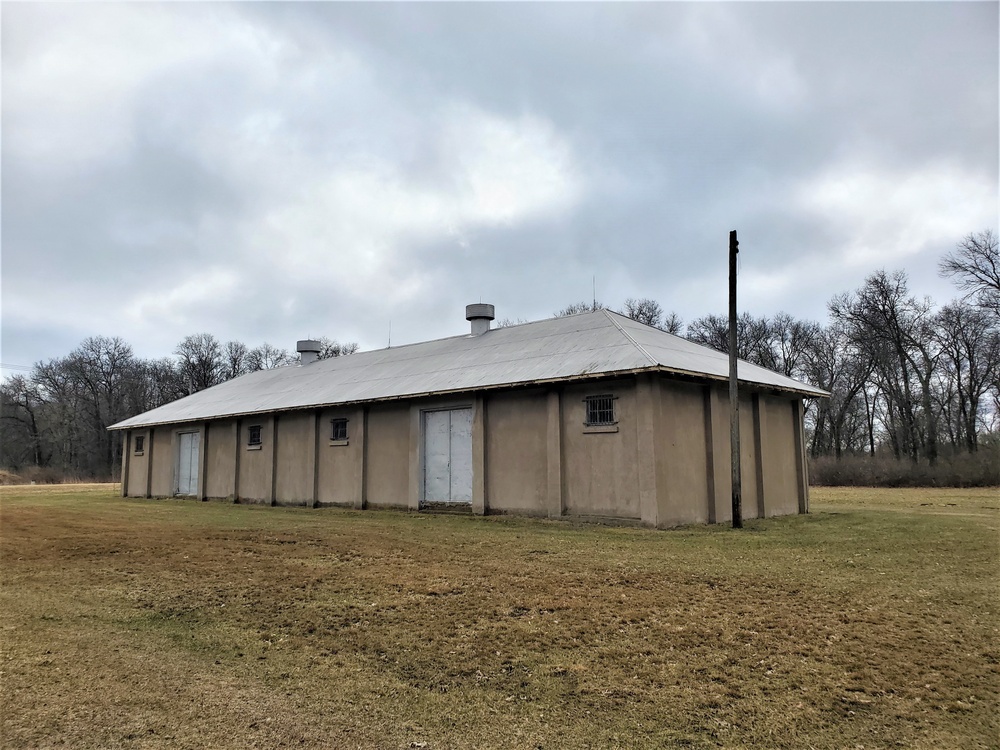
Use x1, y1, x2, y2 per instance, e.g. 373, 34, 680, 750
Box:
110, 310, 827, 429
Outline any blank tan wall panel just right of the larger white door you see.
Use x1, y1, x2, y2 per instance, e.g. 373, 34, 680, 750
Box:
486, 391, 548, 515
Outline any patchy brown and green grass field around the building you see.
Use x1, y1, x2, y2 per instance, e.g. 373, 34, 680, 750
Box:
0, 485, 1000, 750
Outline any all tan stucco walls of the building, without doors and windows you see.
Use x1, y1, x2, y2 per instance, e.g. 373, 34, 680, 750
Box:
123, 374, 808, 528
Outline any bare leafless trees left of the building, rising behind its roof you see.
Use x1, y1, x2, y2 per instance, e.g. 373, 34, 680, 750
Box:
0, 333, 358, 478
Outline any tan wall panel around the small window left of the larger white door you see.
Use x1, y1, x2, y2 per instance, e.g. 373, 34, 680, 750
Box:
316, 409, 365, 508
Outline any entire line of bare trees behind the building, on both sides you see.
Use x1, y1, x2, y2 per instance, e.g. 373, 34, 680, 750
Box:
0, 230, 1000, 484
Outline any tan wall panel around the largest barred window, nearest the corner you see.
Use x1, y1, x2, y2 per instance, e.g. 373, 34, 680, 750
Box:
561, 380, 640, 519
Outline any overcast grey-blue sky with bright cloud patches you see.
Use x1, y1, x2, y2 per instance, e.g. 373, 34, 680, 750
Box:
2, 2, 1000, 374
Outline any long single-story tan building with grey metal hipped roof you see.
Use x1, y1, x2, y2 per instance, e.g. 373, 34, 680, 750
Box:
111, 304, 827, 528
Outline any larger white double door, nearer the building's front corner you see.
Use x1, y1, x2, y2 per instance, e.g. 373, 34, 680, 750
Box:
424, 409, 472, 503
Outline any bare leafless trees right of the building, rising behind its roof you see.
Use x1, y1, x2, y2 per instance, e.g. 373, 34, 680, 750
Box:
556, 230, 1000, 465
